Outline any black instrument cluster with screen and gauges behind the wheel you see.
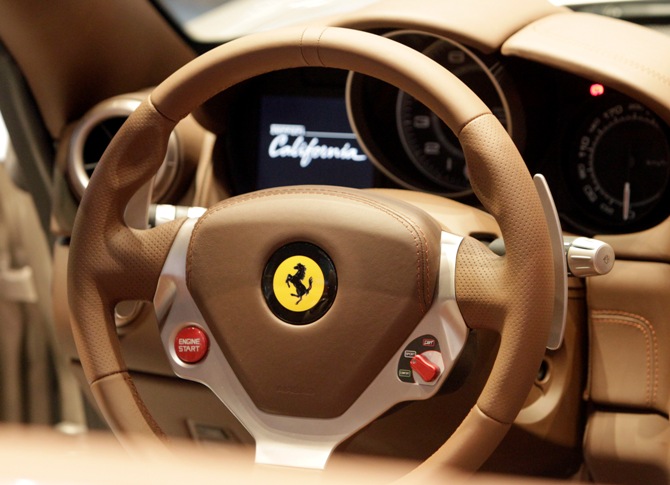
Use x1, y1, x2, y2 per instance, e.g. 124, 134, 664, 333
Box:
203, 31, 670, 235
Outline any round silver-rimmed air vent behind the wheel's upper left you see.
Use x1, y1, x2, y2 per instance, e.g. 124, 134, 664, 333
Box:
68, 95, 180, 202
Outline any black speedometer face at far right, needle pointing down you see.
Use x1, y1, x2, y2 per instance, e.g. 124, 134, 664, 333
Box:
569, 101, 670, 227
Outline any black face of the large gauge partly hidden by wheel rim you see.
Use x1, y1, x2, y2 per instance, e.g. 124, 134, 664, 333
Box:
397, 40, 511, 195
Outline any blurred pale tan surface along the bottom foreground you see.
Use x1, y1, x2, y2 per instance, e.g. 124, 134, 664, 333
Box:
0, 426, 540, 485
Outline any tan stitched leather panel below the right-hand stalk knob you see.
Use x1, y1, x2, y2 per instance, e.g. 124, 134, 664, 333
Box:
587, 260, 670, 413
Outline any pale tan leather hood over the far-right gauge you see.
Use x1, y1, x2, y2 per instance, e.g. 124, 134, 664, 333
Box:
502, 13, 670, 123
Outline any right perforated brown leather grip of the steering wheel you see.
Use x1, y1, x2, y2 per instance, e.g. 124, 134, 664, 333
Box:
456, 115, 554, 423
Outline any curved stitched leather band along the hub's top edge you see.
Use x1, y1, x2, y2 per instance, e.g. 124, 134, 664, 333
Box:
186, 189, 430, 313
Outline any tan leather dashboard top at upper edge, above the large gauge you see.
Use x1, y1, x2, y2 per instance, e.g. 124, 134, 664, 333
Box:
331, 0, 565, 52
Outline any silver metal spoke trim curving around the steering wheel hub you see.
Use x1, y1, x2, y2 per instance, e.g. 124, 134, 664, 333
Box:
154, 223, 468, 469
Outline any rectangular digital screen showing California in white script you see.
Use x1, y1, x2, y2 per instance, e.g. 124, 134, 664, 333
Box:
256, 96, 374, 189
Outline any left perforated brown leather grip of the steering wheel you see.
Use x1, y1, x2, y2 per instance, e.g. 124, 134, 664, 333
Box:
68, 103, 184, 382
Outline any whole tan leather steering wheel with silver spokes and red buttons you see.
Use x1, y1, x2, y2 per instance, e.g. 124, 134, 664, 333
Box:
68, 27, 554, 470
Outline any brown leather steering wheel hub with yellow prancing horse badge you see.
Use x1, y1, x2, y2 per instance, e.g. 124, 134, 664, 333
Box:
186, 187, 441, 419
